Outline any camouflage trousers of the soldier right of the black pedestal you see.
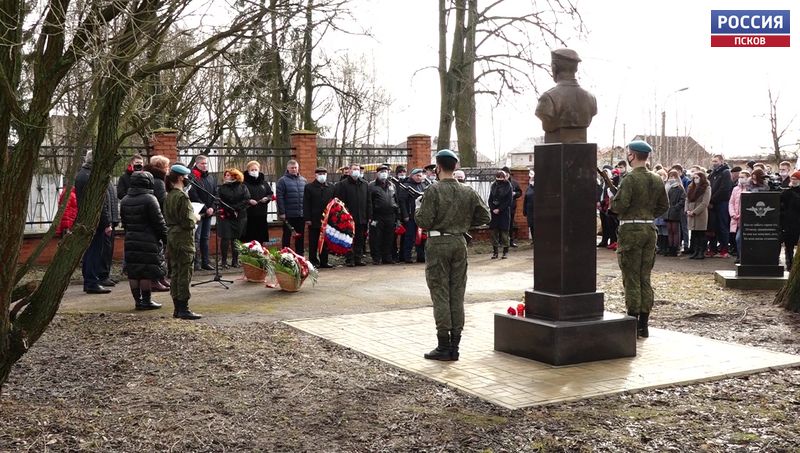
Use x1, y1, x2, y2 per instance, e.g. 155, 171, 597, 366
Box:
617, 224, 656, 313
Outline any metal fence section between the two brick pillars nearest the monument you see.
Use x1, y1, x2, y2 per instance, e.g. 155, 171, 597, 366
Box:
317, 147, 411, 179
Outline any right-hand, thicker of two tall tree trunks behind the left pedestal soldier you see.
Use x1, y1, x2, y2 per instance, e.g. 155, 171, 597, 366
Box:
455, 0, 478, 167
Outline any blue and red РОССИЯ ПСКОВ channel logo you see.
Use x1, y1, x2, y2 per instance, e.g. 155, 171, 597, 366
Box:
711, 9, 790, 47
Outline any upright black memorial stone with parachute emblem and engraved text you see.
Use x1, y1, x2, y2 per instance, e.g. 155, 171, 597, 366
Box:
736, 192, 783, 277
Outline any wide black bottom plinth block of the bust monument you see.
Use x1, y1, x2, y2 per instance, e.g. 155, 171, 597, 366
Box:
494, 312, 636, 365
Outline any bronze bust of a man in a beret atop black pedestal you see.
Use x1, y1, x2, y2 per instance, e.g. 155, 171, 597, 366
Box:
536, 49, 597, 143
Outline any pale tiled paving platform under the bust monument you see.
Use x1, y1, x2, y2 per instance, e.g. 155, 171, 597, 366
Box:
286, 301, 800, 409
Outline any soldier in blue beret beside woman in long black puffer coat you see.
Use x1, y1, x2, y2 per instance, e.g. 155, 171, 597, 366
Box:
164, 164, 202, 319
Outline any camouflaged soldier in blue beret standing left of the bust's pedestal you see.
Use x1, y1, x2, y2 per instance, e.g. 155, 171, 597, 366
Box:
414, 149, 490, 361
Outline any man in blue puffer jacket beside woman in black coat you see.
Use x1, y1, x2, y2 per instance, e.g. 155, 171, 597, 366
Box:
275, 159, 306, 256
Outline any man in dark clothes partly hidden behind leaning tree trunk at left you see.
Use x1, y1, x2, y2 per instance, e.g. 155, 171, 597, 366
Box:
75, 151, 119, 294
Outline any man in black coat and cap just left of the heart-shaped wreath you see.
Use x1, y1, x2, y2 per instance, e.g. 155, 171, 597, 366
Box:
303, 167, 334, 269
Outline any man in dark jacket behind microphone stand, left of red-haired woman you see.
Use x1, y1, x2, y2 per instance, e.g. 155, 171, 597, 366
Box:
189, 154, 217, 271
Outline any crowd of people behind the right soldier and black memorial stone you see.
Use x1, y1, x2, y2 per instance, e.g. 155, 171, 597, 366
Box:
597, 154, 800, 270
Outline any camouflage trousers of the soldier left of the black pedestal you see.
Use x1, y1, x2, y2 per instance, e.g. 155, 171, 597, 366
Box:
425, 235, 467, 331
